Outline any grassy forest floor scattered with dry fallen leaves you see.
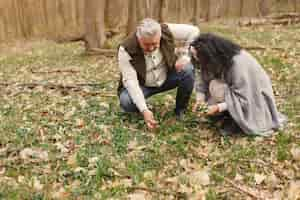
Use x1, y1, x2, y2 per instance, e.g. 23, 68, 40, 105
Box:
0, 24, 300, 200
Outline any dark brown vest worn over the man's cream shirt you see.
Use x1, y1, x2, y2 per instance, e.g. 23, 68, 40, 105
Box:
118, 24, 176, 94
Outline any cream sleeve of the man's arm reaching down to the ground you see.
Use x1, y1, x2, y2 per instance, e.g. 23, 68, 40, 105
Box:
118, 46, 148, 112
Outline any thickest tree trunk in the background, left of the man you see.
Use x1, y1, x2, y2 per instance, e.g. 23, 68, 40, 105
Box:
84, 0, 106, 51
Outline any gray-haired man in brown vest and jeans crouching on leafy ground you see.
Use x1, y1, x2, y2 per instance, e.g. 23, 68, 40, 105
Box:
118, 18, 200, 129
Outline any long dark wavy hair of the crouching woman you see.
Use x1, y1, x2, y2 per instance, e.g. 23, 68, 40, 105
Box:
191, 33, 241, 78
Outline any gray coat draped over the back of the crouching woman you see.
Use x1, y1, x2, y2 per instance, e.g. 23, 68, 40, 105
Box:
225, 50, 287, 136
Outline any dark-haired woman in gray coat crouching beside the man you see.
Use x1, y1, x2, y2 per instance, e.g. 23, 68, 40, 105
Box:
190, 33, 287, 136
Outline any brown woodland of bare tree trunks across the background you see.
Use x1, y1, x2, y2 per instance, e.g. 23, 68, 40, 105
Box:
0, 0, 300, 42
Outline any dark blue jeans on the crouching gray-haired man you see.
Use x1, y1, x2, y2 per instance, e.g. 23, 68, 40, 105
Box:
119, 64, 195, 114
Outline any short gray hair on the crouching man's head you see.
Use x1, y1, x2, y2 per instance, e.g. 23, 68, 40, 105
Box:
136, 18, 161, 38
